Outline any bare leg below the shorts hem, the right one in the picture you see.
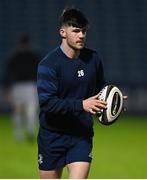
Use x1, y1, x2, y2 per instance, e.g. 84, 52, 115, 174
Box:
67, 162, 90, 179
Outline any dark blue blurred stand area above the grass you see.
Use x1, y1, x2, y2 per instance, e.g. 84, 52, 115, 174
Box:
0, 0, 147, 114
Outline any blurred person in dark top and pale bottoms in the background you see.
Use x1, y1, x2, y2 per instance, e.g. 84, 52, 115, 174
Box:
4, 33, 39, 141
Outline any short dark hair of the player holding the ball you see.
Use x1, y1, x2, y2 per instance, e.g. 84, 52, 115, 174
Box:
59, 8, 89, 28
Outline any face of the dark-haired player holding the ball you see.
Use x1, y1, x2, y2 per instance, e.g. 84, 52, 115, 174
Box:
60, 26, 87, 50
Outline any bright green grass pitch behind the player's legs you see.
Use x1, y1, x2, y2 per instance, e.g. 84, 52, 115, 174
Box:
0, 116, 147, 179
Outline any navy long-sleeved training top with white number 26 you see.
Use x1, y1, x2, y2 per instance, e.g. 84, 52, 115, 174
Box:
37, 47, 105, 137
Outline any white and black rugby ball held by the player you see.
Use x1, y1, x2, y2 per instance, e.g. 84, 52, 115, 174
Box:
96, 85, 123, 125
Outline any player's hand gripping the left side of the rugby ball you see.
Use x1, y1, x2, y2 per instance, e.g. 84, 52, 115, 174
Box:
83, 94, 107, 115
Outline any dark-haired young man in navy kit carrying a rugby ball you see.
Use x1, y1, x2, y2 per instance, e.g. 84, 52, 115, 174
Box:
37, 8, 107, 179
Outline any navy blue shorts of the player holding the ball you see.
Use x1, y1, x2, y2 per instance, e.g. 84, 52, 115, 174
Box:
38, 128, 92, 171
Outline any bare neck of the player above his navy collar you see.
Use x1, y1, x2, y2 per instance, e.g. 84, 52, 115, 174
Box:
61, 42, 80, 58
